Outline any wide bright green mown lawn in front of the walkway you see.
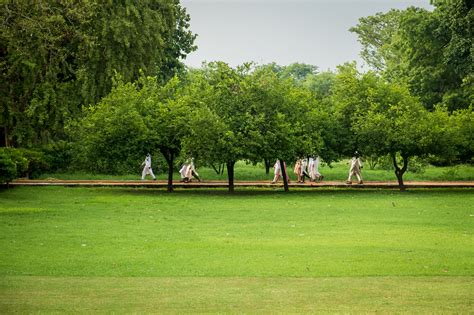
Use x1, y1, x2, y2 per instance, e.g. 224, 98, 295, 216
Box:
0, 187, 474, 314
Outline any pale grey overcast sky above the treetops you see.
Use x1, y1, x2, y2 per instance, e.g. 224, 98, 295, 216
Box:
181, 0, 433, 71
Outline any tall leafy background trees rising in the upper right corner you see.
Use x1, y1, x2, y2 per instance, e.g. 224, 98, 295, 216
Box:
351, 0, 474, 111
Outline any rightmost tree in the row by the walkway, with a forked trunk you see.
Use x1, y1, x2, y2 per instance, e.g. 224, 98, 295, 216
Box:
334, 64, 466, 187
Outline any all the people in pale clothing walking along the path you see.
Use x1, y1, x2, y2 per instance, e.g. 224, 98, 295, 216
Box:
142, 151, 363, 184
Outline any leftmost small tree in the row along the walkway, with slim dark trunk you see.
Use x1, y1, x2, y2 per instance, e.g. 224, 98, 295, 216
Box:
73, 76, 191, 191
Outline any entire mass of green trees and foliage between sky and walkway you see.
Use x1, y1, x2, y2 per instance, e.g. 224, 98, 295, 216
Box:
0, 0, 474, 190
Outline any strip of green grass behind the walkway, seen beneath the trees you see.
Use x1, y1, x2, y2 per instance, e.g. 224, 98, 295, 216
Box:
40, 161, 474, 181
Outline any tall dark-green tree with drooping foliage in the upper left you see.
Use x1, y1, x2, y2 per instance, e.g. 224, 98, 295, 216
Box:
0, 0, 196, 146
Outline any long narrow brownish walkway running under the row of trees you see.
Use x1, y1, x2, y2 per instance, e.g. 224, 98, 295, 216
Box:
10, 179, 474, 188
